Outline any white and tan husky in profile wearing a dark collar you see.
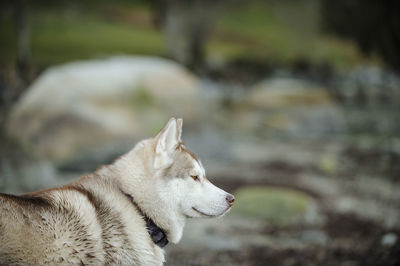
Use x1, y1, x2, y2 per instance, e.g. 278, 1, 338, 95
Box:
0, 118, 235, 265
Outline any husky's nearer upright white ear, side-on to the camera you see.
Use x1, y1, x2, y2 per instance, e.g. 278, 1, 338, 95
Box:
154, 118, 183, 169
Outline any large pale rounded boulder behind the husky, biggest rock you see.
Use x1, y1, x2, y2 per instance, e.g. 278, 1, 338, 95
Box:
9, 56, 203, 162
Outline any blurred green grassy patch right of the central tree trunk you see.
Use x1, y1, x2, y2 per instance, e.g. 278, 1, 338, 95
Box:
208, 1, 363, 67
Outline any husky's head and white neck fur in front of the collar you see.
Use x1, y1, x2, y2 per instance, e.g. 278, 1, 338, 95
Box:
111, 118, 230, 243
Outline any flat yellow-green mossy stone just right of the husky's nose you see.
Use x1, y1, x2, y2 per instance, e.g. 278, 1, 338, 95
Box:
232, 187, 312, 225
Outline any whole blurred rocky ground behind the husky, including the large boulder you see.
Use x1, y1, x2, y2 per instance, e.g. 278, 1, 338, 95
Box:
0, 57, 400, 266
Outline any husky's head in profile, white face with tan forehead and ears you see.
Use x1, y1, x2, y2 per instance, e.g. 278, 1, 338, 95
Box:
153, 118, 235, 218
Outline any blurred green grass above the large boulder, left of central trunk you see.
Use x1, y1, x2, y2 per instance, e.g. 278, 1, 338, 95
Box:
0, 6, 164, 65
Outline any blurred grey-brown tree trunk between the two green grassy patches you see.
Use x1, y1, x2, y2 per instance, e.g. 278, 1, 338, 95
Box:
152, 0, 222, 70
